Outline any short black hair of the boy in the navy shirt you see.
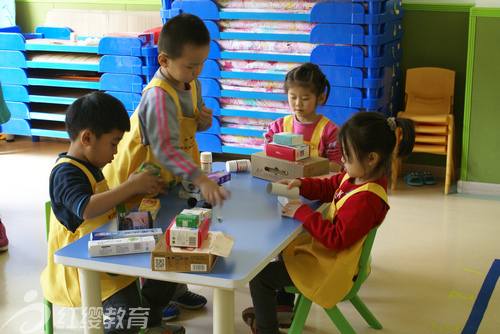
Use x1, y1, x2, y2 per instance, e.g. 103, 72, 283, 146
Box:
66, 92, 130, 141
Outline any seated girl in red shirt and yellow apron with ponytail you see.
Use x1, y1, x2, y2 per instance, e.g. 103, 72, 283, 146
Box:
243, 112, 415, 334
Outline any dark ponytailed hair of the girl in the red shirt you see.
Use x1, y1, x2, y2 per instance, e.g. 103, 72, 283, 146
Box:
339, 111, 415, 173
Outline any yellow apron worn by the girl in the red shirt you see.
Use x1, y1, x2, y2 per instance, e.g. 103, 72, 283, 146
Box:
283, 174, 388, 309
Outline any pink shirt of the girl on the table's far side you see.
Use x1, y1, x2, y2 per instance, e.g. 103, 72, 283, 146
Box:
264, 115, 344, 165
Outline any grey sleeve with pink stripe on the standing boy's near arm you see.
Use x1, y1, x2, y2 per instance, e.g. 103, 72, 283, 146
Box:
139, 87, 202, 181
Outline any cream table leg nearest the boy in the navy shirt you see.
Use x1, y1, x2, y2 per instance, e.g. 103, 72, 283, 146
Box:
78, 268, 104, 334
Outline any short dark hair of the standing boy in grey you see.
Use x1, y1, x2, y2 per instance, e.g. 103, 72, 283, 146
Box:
158, 14, 210, 59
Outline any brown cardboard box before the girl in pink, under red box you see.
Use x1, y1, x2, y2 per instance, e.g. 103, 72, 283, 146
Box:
251, 152, 329, 182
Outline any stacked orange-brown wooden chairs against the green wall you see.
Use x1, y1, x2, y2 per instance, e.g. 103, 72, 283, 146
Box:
391, 67, 455, 195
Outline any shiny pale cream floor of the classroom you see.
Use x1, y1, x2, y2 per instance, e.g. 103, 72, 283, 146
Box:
0, 137, 500, 334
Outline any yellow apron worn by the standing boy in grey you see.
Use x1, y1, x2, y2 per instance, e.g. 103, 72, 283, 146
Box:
103, 78, 200, 210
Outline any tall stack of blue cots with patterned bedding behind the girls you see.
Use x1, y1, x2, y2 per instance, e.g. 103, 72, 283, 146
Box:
161, 0, 404, 154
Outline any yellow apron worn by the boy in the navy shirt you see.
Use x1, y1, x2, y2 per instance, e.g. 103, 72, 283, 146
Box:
40, 158, 136, 307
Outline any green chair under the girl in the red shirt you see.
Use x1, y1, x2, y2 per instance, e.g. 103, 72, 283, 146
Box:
286, 227, 382, 334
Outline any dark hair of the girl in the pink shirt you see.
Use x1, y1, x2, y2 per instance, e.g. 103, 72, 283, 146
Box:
285, 63, 330, 105
